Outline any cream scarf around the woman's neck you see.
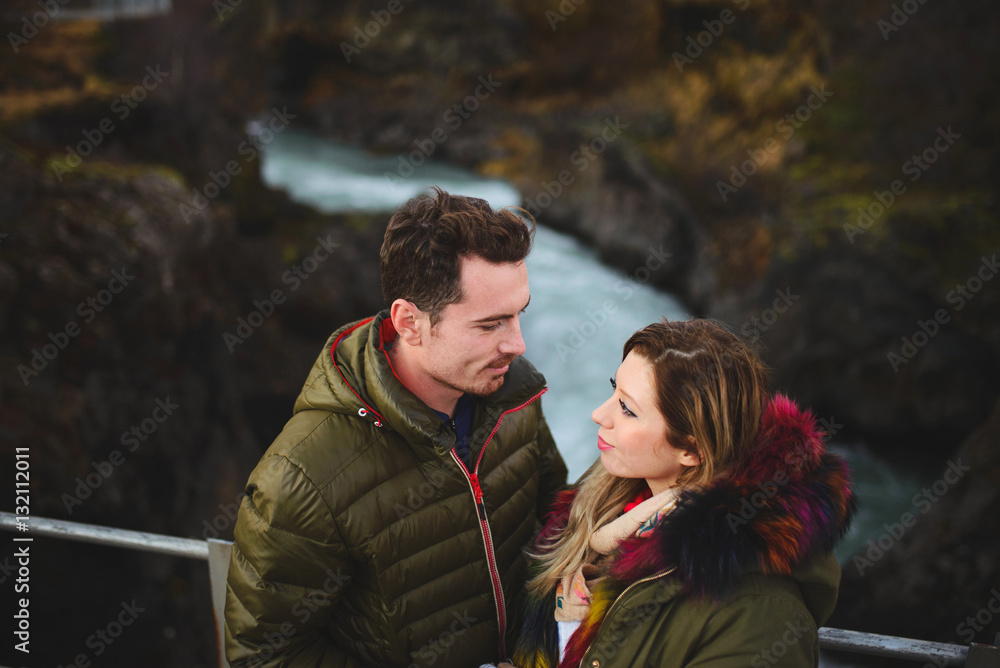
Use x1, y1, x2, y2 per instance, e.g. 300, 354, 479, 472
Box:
555, 487, 680, 622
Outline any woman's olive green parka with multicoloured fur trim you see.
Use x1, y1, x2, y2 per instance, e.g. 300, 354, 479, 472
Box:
514, 395, 856, 668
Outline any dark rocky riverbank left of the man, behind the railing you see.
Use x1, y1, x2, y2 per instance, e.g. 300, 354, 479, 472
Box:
0, 148, 381, 666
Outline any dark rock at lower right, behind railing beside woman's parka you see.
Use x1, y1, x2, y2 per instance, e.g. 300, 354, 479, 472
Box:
830, 403, 1000, 645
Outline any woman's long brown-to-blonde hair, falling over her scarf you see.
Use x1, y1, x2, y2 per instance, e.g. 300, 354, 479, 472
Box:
528, 319, 769, 596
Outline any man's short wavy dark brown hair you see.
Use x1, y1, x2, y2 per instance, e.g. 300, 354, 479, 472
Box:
379, 186, 535, 325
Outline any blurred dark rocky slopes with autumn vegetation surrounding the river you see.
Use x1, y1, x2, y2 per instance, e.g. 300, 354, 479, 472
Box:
0, 0, 1000, 666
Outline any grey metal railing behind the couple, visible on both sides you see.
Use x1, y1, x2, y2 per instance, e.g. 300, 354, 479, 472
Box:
0, 512, 1000, 668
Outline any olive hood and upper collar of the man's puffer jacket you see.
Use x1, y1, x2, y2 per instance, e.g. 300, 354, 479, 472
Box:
293, 310, 545, 453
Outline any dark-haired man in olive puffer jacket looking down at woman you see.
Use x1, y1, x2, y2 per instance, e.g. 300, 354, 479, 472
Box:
226, 189, 566, 668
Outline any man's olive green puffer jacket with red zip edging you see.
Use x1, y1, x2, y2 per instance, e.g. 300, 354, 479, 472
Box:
226, 312, 566, 667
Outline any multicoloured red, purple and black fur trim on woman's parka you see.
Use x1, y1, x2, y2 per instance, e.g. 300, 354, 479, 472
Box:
515, 395, 856, 668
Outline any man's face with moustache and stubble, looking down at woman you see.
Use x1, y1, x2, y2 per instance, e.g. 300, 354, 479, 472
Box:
423, 257, 531, 396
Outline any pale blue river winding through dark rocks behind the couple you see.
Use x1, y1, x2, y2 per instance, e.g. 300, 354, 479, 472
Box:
263, 132, 930, 568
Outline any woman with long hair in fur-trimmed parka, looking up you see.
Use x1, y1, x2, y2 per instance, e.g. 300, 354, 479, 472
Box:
514, 320, 855, 668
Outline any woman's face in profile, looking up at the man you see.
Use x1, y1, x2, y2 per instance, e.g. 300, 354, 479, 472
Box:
590, 351, 701, 494
